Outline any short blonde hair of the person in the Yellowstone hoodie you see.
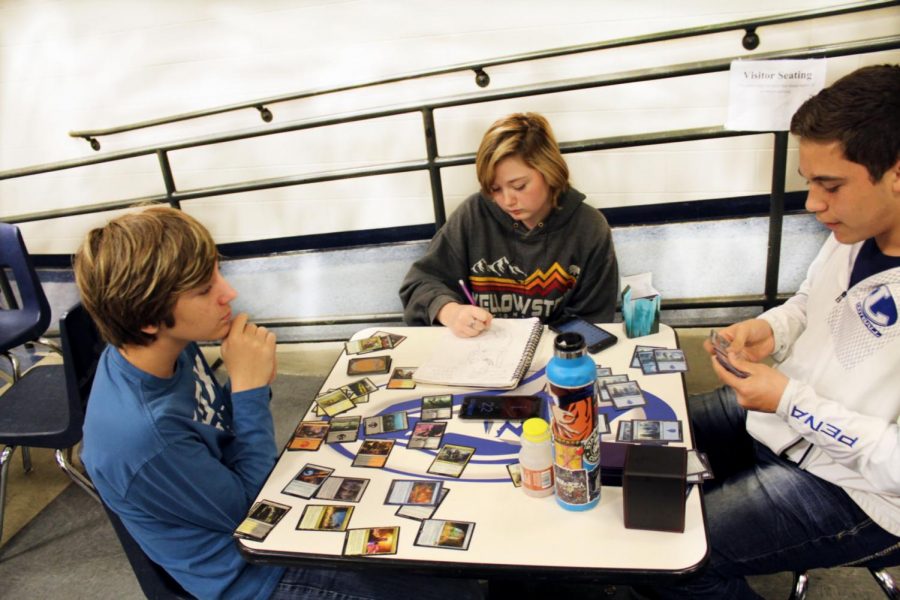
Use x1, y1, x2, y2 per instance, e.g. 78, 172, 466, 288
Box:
475, 113, 569, 206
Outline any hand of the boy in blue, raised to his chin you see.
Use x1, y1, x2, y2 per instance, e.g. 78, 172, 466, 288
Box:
222, 313, 277, 393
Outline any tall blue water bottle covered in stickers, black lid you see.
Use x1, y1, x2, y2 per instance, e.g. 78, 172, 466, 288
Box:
547, 332, 600, 510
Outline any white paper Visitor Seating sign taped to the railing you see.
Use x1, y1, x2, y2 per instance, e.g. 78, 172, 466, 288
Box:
725, 58, 825, 131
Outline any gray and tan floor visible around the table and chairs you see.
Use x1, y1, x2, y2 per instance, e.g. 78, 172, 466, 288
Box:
0, 338, 900, 600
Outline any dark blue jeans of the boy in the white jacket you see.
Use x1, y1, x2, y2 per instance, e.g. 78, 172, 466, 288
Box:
653, 387, 900, 599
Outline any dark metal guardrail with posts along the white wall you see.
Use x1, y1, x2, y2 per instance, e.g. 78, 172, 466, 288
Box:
0, 2, 900, 326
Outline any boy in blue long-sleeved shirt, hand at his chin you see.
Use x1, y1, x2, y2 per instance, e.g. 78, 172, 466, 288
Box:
75, 207, 479, 599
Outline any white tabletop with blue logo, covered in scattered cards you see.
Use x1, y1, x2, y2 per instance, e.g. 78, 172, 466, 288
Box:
237, 324, 708, 581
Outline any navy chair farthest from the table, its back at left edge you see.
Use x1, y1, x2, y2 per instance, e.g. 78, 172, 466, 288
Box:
0, 223, 50, 383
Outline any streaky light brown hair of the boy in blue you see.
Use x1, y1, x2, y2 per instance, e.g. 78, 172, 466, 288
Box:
74, 206, 219, 348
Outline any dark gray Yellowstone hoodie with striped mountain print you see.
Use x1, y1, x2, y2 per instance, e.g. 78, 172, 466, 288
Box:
400, 188, 619, 325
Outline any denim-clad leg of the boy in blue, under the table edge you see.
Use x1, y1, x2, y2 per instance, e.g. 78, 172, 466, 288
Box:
271, 568, 484, 600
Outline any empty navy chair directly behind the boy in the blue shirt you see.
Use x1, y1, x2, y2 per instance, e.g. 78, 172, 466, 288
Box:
0, 305, 103, 535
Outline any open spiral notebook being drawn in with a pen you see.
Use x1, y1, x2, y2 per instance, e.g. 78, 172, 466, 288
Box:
413, 318, 544, 389
